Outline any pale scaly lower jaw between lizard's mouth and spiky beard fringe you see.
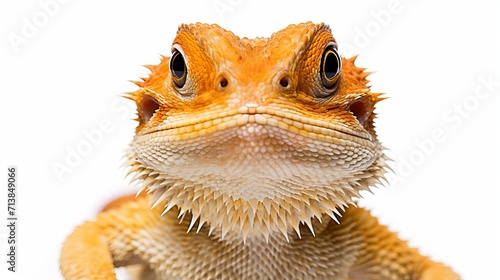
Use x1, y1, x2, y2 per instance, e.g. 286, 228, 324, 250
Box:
132, 115, 377, 201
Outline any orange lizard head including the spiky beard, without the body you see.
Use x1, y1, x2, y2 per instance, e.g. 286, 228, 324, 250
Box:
124, 23, 385, 241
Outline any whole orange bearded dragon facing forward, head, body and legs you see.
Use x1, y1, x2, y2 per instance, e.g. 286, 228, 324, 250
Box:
60, 22, 459, 280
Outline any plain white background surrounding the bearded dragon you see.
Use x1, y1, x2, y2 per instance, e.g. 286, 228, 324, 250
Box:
0, 0, 500, 280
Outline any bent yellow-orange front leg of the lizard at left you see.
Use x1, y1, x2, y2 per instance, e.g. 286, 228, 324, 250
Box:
60, 197, 159, 279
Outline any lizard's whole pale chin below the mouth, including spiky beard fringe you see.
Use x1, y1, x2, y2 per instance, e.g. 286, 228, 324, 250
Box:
124, 112, 386, 240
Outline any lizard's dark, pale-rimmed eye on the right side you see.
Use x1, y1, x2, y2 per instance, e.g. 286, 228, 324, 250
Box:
319, 45, 342, 90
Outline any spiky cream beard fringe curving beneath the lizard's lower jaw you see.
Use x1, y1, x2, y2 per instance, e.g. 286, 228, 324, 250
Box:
128, 148, 387, 242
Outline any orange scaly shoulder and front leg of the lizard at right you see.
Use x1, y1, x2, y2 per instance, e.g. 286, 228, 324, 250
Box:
341, 207, 460, 280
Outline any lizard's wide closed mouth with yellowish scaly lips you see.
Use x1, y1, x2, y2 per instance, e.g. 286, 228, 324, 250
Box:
140, 102, 374, 147
